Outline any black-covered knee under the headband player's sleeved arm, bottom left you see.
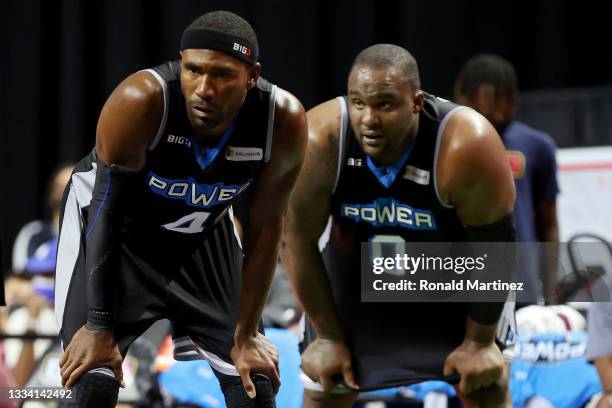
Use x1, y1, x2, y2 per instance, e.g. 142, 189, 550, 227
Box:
59, 372, 119, 408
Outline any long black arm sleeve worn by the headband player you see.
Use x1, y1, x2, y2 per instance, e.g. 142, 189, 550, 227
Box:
85, 162, 131, 329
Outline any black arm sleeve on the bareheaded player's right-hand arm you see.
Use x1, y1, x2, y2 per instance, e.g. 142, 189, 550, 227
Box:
466, 213, 516, 325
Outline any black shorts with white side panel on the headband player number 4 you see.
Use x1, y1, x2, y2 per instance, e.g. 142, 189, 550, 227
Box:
55, 162, 252, 375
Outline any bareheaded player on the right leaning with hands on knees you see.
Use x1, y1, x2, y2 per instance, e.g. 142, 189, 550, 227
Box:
282, 44, 515, 407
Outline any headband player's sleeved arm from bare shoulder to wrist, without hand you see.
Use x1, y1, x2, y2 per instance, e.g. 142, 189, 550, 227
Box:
86, 72, 163, 328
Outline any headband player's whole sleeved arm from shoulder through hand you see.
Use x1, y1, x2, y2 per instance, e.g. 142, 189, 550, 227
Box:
60, 72, 163, 387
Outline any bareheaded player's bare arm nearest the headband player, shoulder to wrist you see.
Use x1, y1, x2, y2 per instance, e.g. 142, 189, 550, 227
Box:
282, 100, 344, 341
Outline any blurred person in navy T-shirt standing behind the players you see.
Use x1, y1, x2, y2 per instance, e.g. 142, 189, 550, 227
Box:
454, 54, 559, 305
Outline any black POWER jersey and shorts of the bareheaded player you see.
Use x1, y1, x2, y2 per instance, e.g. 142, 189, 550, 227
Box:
320, 94, 474, 388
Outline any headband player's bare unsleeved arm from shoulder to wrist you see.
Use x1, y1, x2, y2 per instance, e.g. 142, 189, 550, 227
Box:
235, 89, 307, 344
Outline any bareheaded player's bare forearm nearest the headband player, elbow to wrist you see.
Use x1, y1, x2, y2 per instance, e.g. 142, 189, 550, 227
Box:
281, 235, 344, 341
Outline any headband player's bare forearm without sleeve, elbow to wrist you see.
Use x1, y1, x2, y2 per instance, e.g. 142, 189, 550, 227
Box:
234, 217, 282, 341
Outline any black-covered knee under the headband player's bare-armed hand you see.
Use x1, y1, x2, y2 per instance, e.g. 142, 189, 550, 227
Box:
219, 375, 276, 408
